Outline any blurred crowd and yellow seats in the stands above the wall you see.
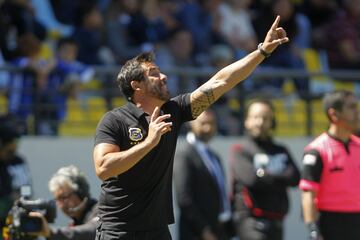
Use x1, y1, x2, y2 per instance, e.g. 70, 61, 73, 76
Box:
0, 0, 360, 135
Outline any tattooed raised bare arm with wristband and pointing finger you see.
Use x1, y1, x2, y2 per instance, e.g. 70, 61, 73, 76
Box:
190, 16, 289, 118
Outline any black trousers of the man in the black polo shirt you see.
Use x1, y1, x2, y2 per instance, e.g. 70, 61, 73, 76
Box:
96, 227, 171, 240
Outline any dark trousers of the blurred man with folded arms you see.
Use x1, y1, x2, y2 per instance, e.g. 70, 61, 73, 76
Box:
236, 216, 283, 240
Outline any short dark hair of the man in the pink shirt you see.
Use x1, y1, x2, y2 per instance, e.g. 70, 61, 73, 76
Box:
323, 90, 354, 121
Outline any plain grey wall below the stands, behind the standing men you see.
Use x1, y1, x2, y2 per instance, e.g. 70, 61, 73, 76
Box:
19, 137, 310, 240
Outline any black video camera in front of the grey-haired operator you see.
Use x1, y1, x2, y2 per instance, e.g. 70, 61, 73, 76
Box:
3, 186, 56, 240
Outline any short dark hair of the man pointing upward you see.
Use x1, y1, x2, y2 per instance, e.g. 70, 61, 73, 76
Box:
116, 52, 155, 100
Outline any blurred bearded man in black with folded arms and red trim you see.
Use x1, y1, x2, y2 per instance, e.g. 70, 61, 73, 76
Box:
232, 100, 300, 240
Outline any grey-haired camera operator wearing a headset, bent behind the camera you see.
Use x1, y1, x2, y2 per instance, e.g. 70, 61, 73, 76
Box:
30, 165, 97, 240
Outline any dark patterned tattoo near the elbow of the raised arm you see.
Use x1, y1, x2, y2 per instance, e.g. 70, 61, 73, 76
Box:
191, 86, 215, 118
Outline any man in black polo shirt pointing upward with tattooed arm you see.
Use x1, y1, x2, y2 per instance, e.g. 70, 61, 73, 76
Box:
93, 16, 289, 240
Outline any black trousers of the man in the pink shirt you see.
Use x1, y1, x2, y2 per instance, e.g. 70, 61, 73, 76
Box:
319, 211, 360, 240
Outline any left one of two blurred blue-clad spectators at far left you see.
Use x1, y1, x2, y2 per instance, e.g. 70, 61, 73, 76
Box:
8, 34, 55, 134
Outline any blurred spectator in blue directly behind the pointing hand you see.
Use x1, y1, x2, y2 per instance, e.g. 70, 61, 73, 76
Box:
254, 0, 310, 95
